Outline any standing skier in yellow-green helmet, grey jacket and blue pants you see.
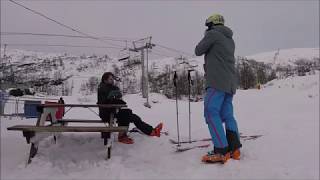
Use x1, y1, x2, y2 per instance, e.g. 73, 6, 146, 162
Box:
195, 14, 242, 163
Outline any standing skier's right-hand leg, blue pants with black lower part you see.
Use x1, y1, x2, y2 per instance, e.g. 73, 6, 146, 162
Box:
221, 94, 242, 158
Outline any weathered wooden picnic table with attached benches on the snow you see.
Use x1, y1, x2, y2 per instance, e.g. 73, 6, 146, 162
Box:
7, 104, 128, 164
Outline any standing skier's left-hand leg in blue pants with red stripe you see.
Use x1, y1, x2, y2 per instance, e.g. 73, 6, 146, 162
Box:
204, 88, 228, 154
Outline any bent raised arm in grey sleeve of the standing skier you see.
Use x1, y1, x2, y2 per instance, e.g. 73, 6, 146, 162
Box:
195, 31, 217, 56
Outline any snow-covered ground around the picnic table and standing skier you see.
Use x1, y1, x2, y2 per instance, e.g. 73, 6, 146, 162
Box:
1, 73, 319, 179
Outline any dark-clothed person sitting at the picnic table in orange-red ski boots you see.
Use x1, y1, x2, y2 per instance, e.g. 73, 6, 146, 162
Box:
97, 72, 163, 144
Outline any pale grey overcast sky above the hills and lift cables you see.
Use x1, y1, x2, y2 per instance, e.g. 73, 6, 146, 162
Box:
1, 0, 319, 56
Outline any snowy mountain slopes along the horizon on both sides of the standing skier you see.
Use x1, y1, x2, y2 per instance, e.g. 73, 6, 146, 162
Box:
0, 48, 320, 95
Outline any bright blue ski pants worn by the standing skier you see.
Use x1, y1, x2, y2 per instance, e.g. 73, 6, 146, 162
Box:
204, 88, 239, 148
